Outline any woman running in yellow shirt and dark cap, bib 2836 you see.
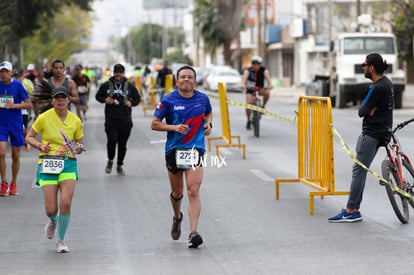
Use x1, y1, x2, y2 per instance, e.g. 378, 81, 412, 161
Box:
26, 86, 83, 253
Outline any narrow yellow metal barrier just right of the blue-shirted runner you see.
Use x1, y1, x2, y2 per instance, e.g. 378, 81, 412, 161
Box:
208, 82, 246, 159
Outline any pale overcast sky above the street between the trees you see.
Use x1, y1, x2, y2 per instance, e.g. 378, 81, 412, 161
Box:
90, 0, 187, 47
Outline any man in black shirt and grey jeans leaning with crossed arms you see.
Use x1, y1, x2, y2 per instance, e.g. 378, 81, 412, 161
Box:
328, 53, 394, 222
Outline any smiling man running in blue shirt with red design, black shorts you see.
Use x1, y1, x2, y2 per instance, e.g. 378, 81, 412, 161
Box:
151, 66, 213, 248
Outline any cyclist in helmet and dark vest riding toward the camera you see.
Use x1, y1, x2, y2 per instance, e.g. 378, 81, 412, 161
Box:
242, 55, 273, 130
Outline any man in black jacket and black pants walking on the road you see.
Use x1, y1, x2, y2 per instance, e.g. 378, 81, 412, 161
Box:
95, 64, 141, 176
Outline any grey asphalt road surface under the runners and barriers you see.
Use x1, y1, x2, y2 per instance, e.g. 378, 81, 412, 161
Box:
0, 87, 414, 274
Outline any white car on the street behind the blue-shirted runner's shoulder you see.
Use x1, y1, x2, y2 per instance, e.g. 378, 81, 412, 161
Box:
205, 66, 242, 92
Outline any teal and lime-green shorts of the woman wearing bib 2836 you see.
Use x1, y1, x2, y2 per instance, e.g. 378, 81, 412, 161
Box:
36, 159, 78, 187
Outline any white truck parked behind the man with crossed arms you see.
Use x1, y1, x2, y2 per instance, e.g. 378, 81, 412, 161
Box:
332, 32, 406, 109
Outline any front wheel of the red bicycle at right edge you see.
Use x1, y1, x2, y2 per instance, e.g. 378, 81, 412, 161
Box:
381, 160, 410, 224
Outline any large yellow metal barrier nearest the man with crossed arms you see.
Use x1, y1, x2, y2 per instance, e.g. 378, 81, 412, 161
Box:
276, 95, 349, 215
